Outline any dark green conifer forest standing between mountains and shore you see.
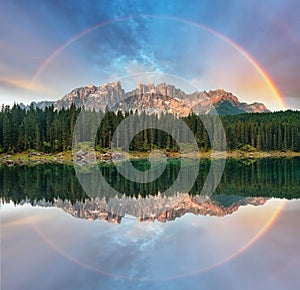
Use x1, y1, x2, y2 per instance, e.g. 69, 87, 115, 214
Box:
0, 104, 300, 153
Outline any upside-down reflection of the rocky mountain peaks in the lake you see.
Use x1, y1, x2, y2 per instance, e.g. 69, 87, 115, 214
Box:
28, 194, 267, 223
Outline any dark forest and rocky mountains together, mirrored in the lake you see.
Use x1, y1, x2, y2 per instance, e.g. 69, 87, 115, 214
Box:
0, 158, 300, 223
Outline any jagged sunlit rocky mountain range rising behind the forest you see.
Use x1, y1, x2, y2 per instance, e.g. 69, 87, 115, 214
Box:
21, 82, 269, 117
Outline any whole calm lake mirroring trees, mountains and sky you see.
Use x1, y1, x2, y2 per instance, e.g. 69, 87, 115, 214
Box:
0, 158, 300, 290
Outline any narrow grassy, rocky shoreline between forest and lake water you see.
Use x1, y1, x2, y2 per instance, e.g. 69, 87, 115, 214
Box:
0, 150, 300, 166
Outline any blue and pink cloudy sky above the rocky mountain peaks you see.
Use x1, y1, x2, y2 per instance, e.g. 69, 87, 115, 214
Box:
0, 0, 300, 110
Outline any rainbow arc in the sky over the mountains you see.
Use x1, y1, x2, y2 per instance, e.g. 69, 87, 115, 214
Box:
27, 14, 287, 109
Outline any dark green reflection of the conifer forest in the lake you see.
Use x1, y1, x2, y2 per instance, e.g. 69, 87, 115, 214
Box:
0, 158, 300, 203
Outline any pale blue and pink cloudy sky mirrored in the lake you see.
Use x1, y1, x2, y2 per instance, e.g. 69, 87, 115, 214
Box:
1, 199, 300, 290
